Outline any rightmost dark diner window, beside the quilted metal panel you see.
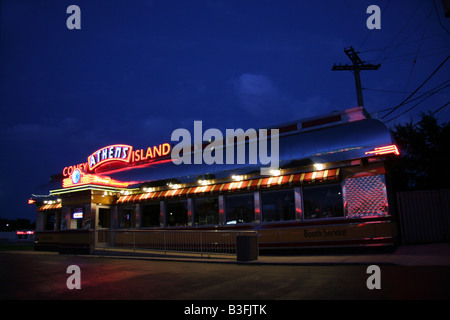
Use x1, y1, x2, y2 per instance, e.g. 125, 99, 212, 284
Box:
303, 184, 344, 219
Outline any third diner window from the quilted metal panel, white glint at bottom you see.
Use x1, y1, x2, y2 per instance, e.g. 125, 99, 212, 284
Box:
225, 193, 255, 224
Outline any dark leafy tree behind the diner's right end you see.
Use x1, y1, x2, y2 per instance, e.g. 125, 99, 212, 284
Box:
391, 113, 450, 191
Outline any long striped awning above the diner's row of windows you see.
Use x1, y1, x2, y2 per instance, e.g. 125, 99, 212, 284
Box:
117, 168, 340, 204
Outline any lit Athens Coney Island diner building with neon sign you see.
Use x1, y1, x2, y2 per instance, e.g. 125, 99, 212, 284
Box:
29, 107, 399, 250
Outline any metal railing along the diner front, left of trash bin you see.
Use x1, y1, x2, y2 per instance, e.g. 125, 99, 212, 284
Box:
93, 229, 257, 257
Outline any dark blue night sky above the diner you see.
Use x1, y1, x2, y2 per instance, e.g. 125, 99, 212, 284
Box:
0, 0, 450, 220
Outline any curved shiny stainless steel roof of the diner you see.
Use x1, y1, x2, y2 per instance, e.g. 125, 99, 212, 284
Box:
108, 119, 393, 182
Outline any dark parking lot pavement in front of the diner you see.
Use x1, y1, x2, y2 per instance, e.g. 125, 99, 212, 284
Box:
0, 244, 450, 302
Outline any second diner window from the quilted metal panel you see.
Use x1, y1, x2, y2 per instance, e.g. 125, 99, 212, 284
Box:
261, 189, 295, 222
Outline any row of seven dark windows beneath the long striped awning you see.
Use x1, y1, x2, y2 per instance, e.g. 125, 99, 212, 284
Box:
118, 184, 344, 228
